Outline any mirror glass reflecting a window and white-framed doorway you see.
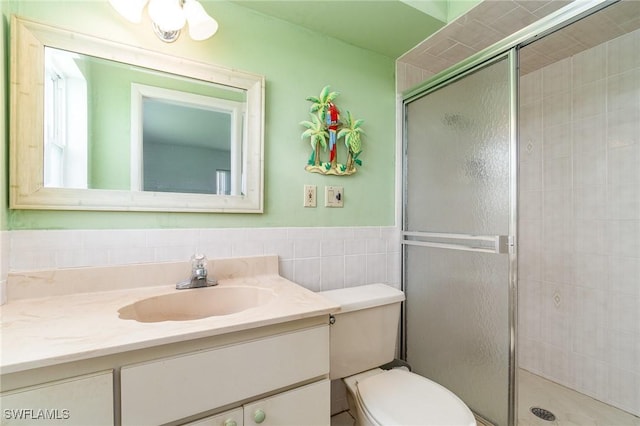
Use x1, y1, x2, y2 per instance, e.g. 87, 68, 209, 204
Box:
44, 47, 246, 195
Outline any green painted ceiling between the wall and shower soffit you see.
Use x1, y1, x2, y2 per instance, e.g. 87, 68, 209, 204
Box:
232, 0, 447, 59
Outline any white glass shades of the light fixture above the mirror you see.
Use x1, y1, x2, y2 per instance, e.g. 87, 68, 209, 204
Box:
109, 0, 218, 43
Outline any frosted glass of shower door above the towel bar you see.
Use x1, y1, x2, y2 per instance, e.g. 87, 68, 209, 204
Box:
405, 61, 510, 234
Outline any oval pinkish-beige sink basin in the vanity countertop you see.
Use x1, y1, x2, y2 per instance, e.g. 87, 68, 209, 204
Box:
118, 286, 276, 322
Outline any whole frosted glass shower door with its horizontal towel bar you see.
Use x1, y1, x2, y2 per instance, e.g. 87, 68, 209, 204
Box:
403, 53, 516, 425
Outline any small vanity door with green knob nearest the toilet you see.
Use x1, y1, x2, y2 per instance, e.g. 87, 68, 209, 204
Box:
244, 380, 331, 426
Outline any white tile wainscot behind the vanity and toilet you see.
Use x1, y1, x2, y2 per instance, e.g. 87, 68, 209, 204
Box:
5, 227, 400, 291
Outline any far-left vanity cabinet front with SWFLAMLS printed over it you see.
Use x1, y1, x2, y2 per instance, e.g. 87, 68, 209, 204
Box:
0, 371, 113, 426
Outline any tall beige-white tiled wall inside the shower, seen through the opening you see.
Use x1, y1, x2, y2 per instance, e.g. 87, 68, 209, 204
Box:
519, 30, 640, 415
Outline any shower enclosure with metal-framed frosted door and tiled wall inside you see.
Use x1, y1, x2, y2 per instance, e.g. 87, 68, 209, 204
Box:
403, 1, 640, 425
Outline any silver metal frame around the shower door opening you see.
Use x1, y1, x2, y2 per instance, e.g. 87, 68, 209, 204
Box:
400, 0, 619, 425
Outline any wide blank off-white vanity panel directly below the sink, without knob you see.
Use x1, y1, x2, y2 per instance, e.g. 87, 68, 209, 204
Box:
120, 325, 329, 426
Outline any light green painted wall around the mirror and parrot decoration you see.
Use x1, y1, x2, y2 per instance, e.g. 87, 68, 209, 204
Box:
2, 0, 395, 229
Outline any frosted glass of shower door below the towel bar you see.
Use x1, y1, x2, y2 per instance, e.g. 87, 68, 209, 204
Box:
405, 246, 509, 425
